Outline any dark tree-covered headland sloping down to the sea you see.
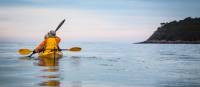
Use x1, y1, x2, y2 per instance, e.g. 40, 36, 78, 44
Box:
140, 17, 200, 44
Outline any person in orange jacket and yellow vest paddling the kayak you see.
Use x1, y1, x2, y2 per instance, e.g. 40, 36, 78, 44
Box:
29, 30, 61, 57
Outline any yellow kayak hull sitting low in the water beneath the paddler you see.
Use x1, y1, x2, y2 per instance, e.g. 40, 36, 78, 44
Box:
38, 51, 63, 59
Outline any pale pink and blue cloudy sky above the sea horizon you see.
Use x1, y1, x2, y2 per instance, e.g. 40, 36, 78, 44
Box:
0, 0, 200, 42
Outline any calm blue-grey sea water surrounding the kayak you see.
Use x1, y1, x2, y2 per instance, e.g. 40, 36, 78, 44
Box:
0, 42, 200, 87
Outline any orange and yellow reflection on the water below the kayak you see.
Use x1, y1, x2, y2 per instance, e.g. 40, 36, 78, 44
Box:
38, 58, 60, 87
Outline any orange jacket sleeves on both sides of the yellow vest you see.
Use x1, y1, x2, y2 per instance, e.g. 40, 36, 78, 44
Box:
35, 36, 61, 53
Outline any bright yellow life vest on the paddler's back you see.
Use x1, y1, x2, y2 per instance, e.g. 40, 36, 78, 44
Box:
44, 37, 58, 52
